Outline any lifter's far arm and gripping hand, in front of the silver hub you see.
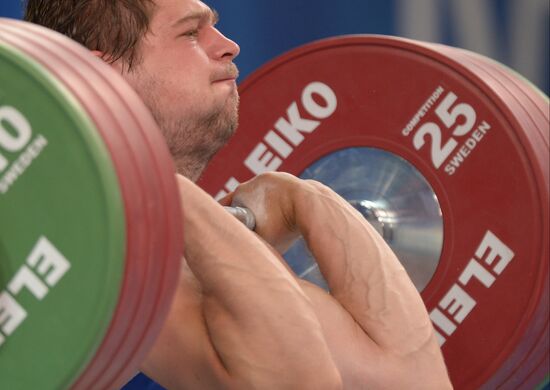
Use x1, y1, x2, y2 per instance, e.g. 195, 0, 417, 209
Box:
222, 173, 452, 389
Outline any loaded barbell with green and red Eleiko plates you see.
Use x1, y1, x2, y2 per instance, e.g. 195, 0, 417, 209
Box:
0, 19, 549, 389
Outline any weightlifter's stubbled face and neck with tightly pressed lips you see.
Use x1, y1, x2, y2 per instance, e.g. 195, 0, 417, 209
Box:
123, 0, 239, 180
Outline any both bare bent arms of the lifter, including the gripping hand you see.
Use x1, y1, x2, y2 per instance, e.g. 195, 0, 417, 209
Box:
144, 173, 452, 389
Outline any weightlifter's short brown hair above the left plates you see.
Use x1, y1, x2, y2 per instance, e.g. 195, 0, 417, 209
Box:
24, 0, 155, 68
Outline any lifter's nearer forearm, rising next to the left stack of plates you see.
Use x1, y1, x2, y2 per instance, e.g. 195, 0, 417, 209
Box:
180, 176, 337, 388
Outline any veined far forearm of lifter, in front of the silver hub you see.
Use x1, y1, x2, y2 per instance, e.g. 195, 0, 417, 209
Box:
293, 182, 434, 352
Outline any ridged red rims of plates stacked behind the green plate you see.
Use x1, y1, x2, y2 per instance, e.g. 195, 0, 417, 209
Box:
2, 20, 181, 388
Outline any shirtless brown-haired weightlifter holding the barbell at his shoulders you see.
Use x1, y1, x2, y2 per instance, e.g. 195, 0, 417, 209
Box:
26, 0, 451, 389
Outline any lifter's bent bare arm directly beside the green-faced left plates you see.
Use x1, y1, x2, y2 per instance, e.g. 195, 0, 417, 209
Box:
143, 176, 342, 389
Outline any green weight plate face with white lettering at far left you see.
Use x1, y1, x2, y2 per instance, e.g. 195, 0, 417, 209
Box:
0, 38, 125, 389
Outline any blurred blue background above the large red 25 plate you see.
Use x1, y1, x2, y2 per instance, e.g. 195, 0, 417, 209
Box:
0, 0, 550, 389
